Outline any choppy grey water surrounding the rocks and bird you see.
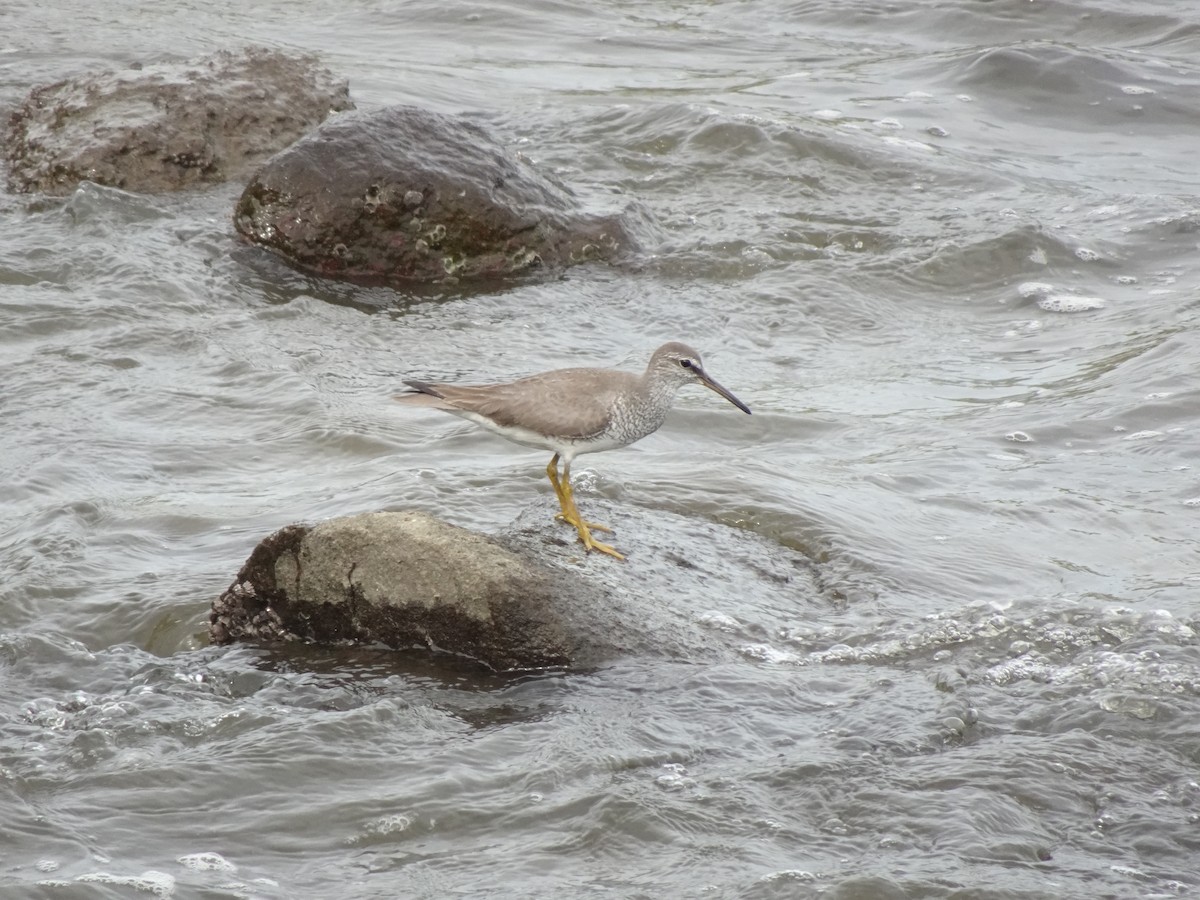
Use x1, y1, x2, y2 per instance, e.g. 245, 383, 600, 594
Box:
0, 0, 1200, 898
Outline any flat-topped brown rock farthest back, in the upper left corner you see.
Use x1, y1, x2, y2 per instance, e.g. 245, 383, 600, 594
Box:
4, 48, 354, 196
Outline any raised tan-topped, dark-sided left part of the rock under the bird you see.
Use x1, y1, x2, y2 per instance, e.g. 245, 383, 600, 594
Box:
210, 512, 604, 670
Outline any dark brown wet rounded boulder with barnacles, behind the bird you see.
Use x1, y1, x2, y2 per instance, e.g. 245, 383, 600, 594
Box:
234, 107, 632, 283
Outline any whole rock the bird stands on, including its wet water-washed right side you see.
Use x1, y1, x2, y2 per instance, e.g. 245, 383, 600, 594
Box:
210, 503, 829, 671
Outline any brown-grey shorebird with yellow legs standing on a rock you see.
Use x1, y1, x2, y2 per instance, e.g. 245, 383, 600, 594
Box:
396, 341, 750, 559
